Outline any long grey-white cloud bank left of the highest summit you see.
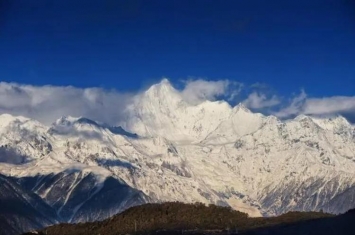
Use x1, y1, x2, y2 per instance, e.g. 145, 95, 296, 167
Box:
0, 82, 133, 124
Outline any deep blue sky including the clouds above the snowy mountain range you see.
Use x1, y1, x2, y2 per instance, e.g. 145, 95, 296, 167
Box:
0, 0, 355, 122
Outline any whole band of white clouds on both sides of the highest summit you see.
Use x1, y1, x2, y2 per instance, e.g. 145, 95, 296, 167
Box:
0, 79, 355, 125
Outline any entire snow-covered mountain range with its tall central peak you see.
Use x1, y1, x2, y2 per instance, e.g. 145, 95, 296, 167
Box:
0, 80, 355, 233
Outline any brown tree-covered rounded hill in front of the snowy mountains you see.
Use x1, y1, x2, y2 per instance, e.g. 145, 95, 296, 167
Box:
29, 202, 332, 235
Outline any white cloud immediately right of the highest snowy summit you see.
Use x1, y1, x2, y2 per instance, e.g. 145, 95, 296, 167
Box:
181, 79, 242, 104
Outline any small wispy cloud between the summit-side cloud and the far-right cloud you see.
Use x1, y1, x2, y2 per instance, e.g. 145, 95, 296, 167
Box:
243, 91, 281, 109
